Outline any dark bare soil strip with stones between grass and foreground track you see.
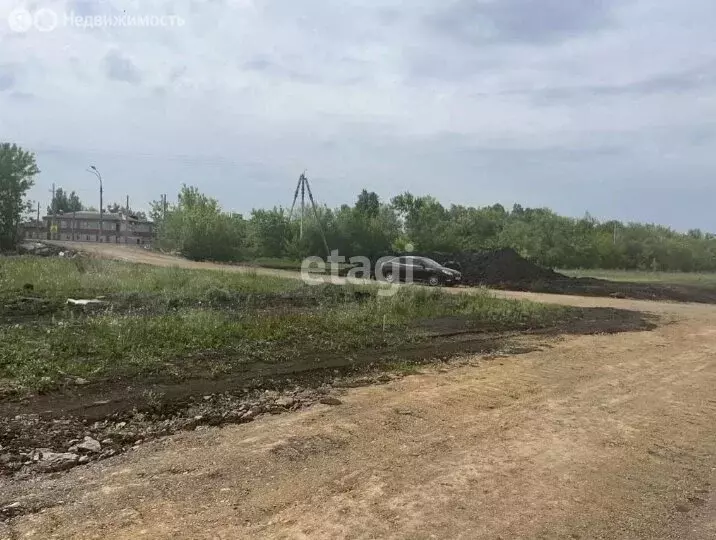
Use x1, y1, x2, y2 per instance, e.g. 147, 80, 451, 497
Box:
0, 308, 654, 476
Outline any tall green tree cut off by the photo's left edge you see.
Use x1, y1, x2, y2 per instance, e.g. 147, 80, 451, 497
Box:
0, 143, 40, 250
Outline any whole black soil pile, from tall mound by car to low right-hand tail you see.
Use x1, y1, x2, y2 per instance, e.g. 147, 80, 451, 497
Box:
421, 248, 716, 304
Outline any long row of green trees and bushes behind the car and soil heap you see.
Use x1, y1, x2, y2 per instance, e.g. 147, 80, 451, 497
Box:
151, 186, 716, 272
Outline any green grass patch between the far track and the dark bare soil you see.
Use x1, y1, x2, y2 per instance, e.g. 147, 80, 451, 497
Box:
0, 258, 567, 390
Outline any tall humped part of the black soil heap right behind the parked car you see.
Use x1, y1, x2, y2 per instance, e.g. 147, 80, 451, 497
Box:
416, 248, 568, 287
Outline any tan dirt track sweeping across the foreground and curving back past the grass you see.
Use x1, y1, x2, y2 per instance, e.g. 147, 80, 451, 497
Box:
0, 247, 716, 539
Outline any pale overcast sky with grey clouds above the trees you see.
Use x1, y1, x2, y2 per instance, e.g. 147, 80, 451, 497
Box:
0, 0, 716, 232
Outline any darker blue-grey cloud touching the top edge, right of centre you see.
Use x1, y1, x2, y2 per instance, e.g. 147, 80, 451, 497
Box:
429, 0, 612, 44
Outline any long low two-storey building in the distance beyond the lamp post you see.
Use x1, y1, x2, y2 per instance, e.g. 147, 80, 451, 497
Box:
22, 212, 154, 245
